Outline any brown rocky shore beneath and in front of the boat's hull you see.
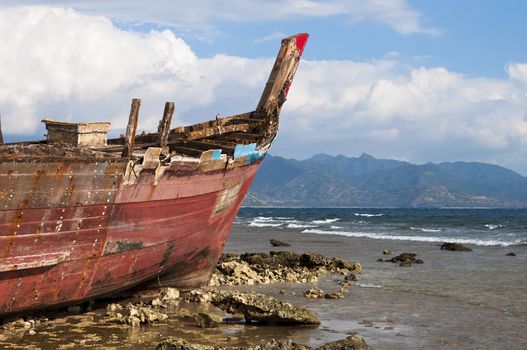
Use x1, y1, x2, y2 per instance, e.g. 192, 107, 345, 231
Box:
0, 251, 371, 350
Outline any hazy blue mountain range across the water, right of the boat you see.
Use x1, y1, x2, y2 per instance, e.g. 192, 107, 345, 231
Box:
245, 154, 527, 208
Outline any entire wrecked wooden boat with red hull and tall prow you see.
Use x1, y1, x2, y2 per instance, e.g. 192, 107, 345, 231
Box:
0, 33, 308, 315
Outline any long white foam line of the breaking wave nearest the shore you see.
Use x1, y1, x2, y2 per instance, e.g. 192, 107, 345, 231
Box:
302, 229, 522, 247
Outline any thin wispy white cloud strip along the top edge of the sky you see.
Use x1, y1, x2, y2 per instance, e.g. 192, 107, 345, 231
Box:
0, 0, 439, 38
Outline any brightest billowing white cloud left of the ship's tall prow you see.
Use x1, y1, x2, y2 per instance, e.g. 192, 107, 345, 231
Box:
0, 7, 271, 134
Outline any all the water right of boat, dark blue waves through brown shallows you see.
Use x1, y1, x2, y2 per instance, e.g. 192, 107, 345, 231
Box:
225, 208, 527, 350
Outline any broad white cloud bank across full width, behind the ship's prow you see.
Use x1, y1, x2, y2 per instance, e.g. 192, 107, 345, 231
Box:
0, 7, 527, 174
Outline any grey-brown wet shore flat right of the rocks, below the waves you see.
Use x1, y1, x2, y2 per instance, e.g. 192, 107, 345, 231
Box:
225, 224, 527, 349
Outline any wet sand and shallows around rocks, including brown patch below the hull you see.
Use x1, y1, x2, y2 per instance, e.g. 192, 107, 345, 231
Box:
0, 225, 527, 350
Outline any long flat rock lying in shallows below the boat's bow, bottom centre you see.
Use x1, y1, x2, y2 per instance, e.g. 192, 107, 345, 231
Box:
212, 290, 320, 325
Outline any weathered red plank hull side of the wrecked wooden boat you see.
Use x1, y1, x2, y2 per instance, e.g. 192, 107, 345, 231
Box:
0, 161, 260, 314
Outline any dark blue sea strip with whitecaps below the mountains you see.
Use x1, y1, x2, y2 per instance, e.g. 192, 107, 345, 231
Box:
235, 207, 527, 247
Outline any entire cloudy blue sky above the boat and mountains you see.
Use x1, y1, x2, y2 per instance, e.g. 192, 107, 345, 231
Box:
0, 0, 527, 176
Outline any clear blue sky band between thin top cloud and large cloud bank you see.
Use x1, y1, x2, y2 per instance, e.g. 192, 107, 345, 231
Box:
155, 0, 527, 78
